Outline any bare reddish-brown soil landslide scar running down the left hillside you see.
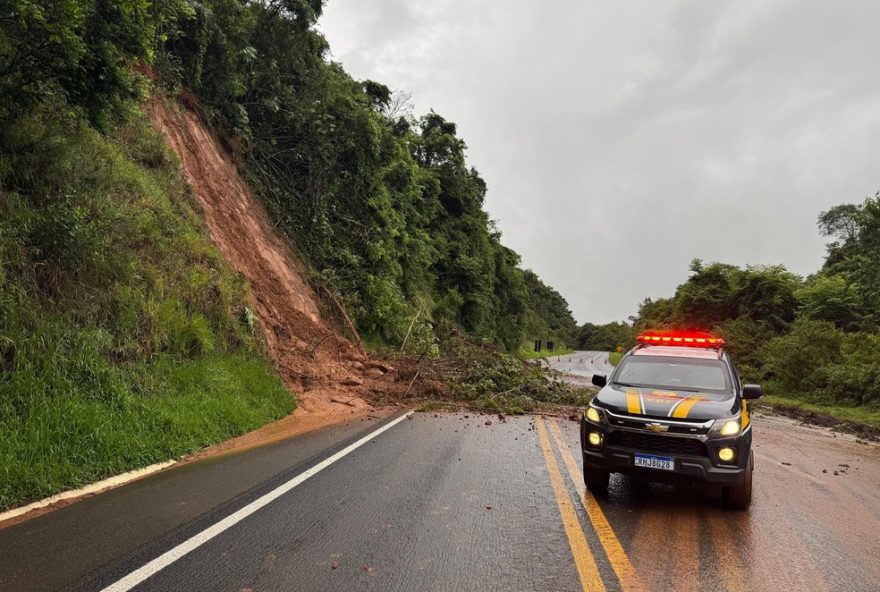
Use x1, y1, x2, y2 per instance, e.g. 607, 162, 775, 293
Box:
146, 97, 394, 420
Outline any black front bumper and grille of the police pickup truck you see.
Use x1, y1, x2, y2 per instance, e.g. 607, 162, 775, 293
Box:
581, 417, 752, 485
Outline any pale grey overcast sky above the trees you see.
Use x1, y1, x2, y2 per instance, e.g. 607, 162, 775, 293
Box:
320, 0, 880, 323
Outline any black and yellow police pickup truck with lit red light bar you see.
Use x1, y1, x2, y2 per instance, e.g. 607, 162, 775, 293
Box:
581, 331, 763, 509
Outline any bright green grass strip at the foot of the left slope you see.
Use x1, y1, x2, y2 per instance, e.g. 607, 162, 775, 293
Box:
0, 355, 294, 509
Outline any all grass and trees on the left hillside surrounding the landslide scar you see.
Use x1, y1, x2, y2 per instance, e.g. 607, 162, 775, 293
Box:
0, 0, 575, 507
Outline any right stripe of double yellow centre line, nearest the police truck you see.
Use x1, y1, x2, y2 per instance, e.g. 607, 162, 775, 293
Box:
550, 421, 645, 592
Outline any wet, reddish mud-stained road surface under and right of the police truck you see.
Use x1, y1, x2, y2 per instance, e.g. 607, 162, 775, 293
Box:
562, 394, 880, 592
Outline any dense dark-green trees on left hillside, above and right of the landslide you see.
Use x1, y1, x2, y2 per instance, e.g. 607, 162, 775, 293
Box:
0, 0, 575, 351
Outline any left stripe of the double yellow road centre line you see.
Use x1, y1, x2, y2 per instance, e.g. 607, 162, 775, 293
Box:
535, 415, 605, 592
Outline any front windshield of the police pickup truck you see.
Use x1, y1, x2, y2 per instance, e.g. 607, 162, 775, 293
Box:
612, 356, 732, 393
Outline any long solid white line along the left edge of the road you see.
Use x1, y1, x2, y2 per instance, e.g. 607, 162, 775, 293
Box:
101, 411, 414, 592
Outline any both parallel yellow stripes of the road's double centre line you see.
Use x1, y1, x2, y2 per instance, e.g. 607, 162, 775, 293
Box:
535, 416, 645, 592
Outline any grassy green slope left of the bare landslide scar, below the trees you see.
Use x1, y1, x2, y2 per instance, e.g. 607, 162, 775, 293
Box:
0, 98, 293, 508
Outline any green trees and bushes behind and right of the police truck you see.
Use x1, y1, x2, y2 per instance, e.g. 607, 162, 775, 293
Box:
575, 194, 880, 406
